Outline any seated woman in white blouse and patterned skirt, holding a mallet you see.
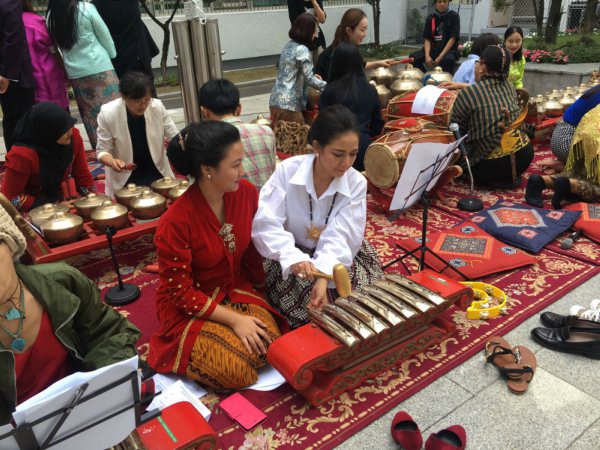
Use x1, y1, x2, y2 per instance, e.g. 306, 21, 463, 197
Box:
252, 105, 382, 327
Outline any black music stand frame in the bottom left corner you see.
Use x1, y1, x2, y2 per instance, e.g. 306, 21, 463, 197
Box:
0, 370, 160, 450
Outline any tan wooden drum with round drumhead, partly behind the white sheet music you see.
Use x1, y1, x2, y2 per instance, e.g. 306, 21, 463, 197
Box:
364, 129, 455, 189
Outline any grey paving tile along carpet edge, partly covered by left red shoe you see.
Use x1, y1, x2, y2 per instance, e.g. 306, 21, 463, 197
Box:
336, 377, 471, 450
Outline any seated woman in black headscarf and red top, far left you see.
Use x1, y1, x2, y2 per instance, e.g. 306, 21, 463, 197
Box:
2, 102, 96, 211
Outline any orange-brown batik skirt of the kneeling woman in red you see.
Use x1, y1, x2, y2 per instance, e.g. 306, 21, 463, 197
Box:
186, 298, 281, 390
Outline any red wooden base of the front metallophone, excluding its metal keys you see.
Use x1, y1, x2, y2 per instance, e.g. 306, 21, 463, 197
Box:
267, 269, 473, 406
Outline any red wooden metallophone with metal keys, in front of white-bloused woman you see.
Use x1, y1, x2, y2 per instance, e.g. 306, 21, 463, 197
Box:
267, 269, 473, 406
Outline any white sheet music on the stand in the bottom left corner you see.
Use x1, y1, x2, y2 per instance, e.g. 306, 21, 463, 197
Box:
13, 356, 138, 450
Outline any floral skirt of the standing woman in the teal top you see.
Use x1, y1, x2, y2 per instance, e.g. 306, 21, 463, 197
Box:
70, 70, 119, 150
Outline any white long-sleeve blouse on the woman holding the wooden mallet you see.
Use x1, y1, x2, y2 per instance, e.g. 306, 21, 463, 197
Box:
252, 155, 367, 279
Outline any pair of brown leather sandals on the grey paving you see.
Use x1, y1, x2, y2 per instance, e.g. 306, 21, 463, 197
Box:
485, 336, 537, 395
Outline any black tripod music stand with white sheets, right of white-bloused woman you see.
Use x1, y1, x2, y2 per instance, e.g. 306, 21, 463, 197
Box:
383, 139, 470, 280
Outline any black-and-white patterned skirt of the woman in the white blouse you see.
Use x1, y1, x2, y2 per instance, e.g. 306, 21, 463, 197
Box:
264, 240, 383, 328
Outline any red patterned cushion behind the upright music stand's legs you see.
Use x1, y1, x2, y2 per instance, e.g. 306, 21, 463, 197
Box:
397, 220, 536, 279
